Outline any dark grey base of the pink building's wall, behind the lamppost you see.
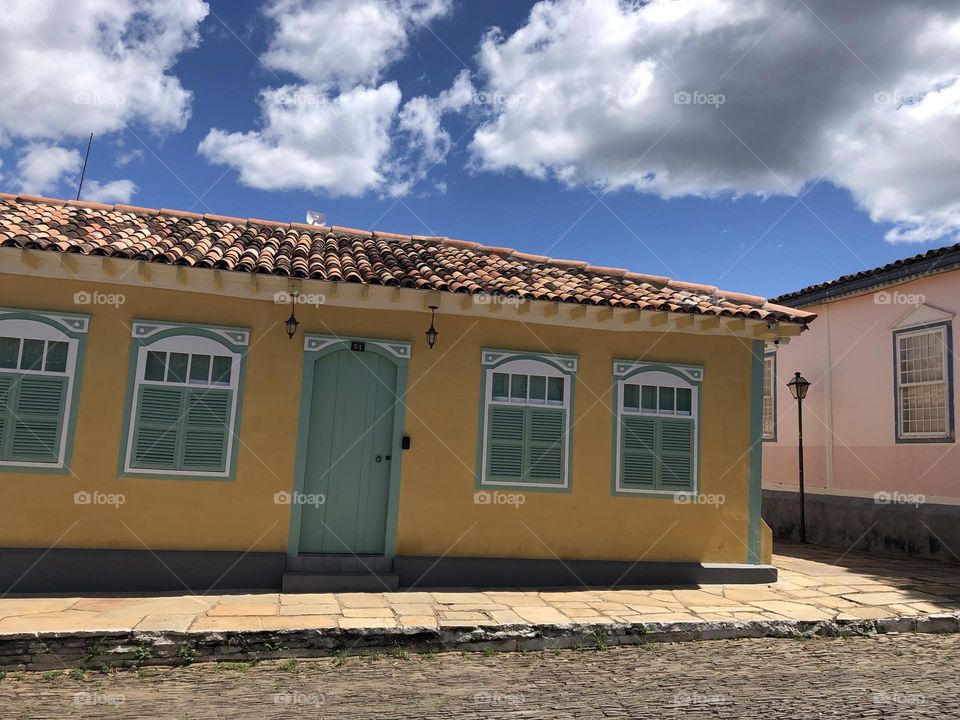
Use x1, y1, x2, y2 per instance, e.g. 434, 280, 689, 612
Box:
762, 490, 960, 562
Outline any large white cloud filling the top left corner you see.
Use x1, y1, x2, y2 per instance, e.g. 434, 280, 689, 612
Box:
0, 0, 207, 141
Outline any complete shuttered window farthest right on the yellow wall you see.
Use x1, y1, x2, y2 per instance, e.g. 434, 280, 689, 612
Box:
614, 360, 703, 494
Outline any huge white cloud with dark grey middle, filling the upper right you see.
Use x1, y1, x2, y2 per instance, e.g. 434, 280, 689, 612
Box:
471, 0, 960, 241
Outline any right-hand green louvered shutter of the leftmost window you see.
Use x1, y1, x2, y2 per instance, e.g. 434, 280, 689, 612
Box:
4, 375, 68, 463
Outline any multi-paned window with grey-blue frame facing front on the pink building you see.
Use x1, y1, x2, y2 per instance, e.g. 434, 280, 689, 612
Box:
894, 324, 953, 442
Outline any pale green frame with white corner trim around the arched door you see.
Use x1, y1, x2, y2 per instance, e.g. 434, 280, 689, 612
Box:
287, 333, 411, 558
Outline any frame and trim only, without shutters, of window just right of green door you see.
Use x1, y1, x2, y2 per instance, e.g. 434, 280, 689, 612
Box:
480, 350, 577, 490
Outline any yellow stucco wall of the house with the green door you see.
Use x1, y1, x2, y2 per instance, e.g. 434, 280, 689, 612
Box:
0, 275, 751, 562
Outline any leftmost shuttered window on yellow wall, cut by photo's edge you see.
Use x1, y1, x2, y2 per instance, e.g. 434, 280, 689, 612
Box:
0, 309, 88, 470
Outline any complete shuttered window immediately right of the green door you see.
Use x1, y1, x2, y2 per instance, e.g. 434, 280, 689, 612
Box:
479, 350, 577, 488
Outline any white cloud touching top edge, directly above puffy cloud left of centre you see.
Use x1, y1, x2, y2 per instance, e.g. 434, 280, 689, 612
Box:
263, 0, 450, 87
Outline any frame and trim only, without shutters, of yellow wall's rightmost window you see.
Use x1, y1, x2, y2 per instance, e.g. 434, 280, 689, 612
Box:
613, 360, 703, 497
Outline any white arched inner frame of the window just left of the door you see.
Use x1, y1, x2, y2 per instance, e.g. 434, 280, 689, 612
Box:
123, 327, 243, 478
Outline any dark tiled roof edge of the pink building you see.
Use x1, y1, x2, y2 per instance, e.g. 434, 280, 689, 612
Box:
772, 243, 960, 307
